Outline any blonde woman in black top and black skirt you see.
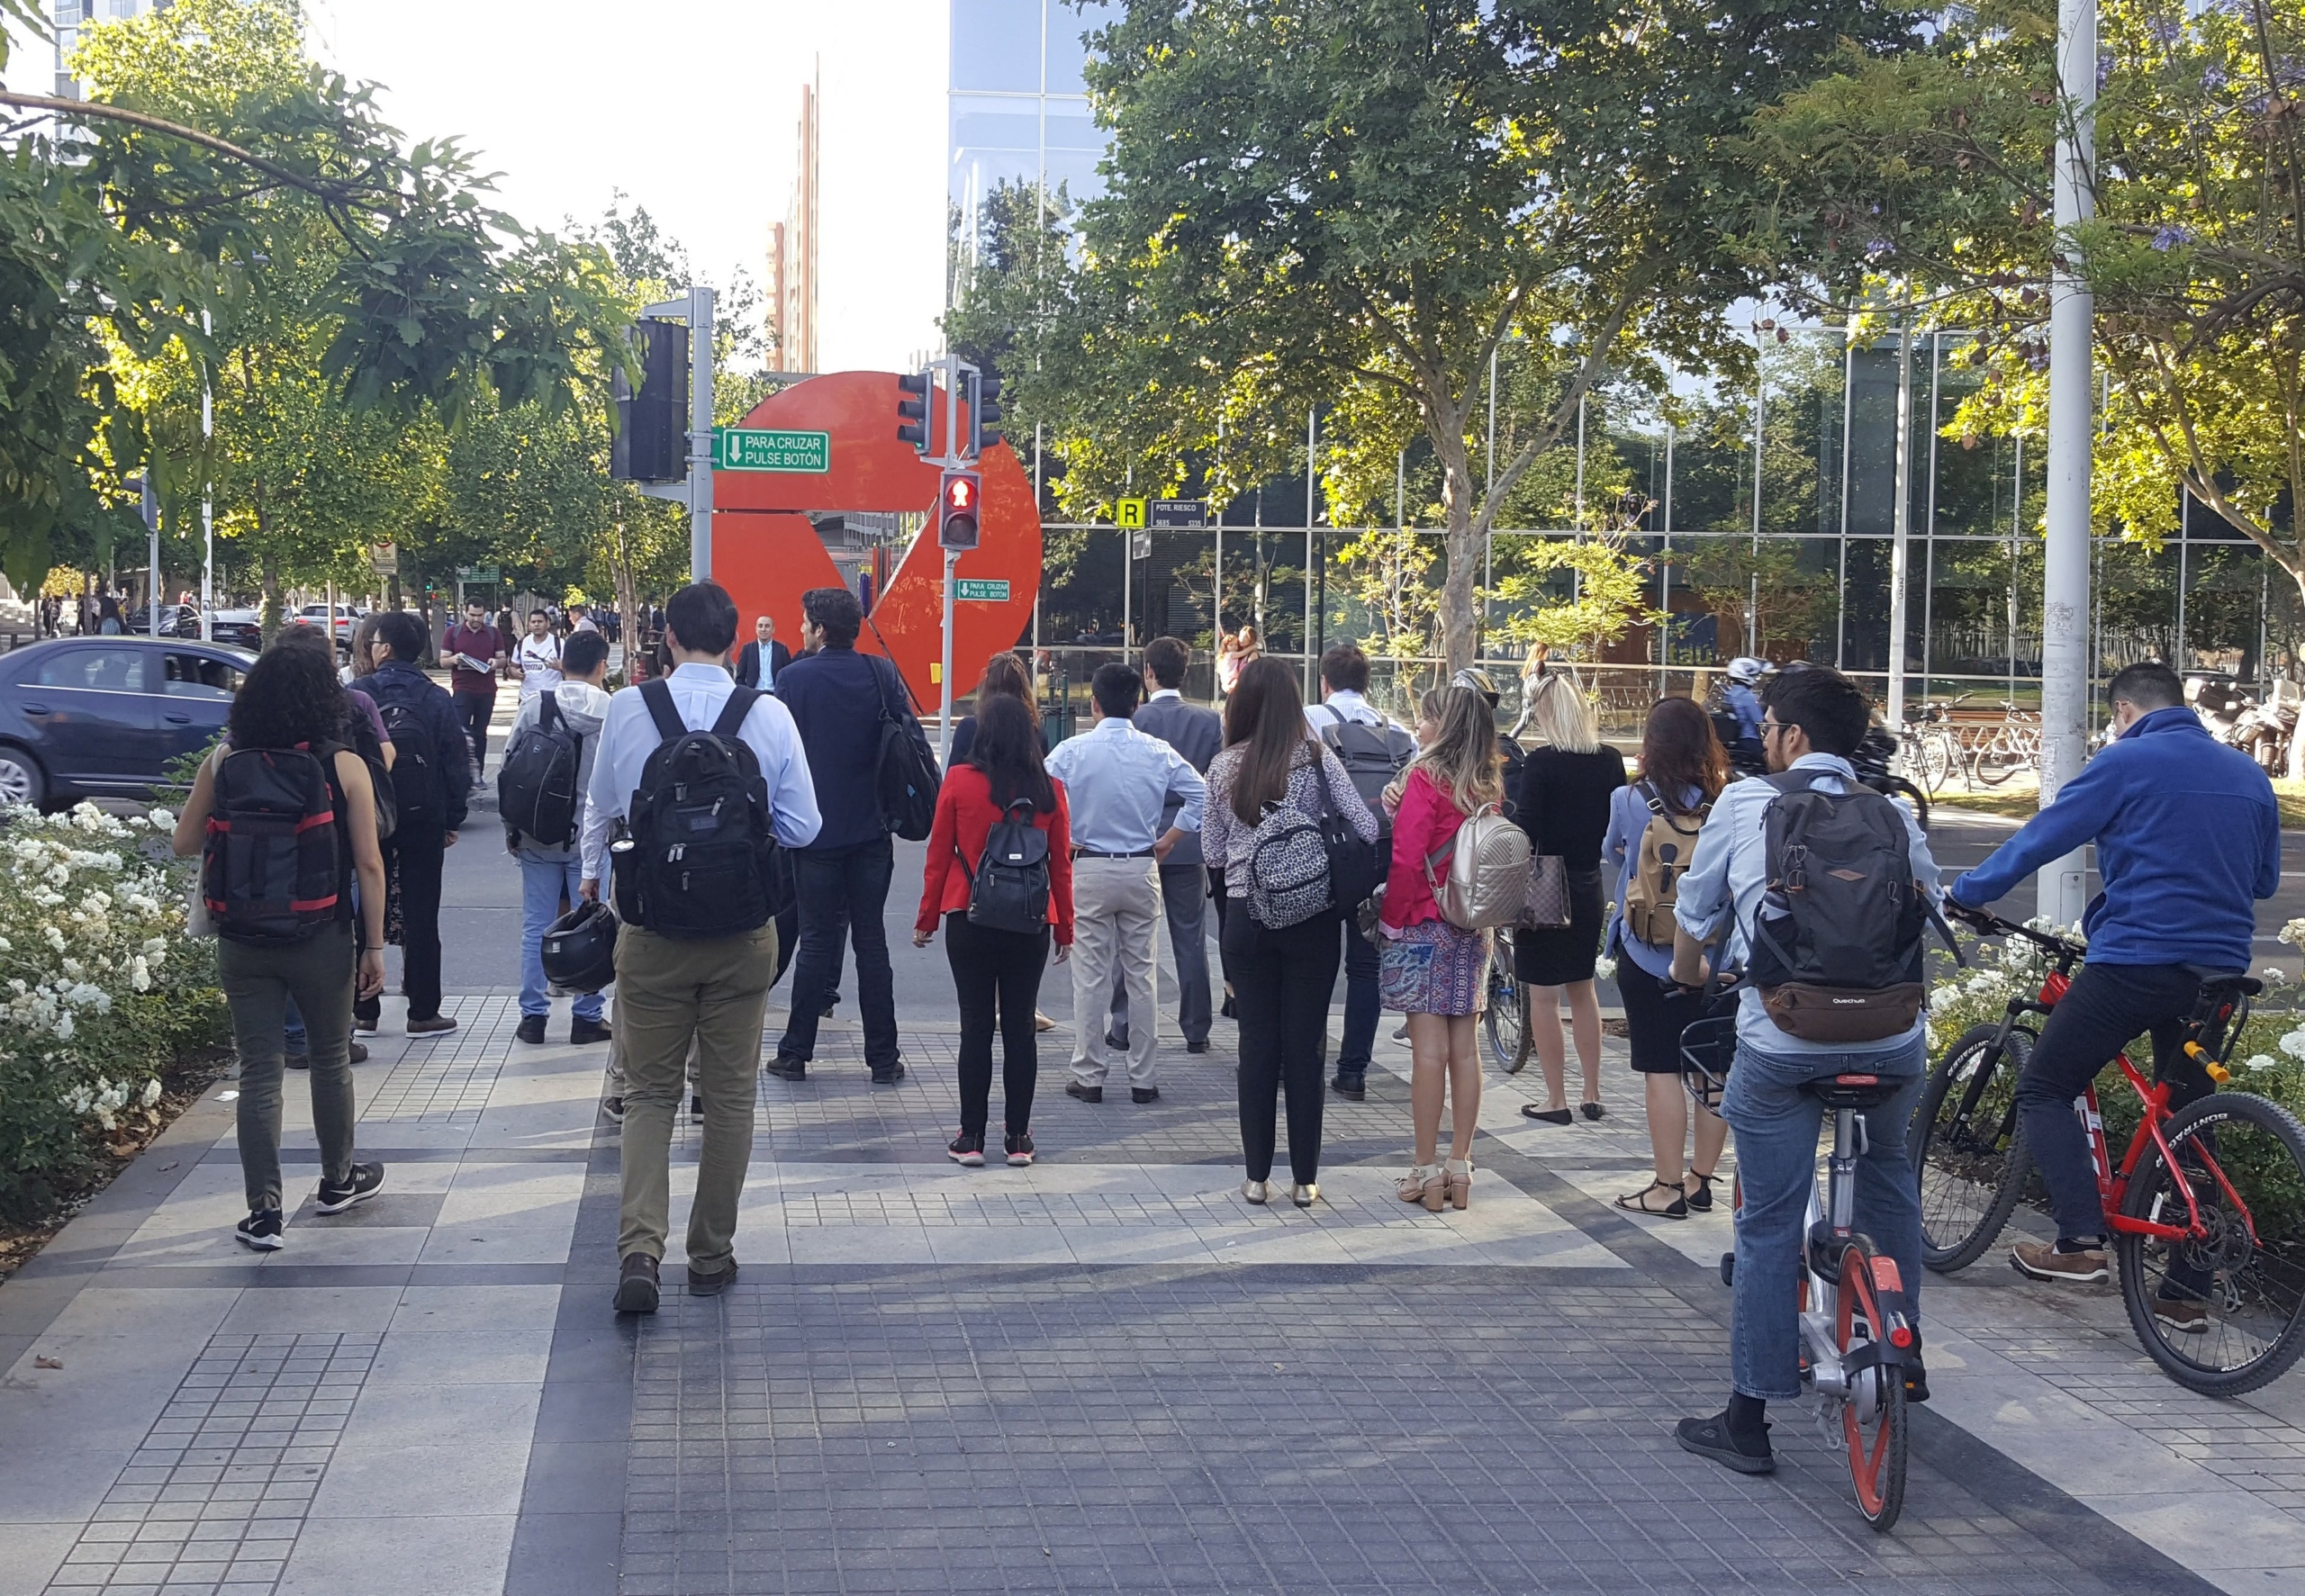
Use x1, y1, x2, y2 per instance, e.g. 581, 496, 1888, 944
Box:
1512, 677, 1625, 1124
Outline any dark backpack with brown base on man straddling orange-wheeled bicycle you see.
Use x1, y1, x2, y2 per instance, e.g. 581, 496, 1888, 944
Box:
1747, 771, 1950, 1043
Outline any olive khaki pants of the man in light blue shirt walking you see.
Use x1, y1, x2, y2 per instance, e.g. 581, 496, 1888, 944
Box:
616, 925, 777, 1274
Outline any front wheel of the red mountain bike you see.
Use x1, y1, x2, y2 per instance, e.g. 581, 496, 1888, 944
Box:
1904, 1025, 2033, 1274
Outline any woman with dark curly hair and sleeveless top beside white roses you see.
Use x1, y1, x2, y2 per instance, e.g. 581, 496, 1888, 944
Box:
176, 643, 385, 1253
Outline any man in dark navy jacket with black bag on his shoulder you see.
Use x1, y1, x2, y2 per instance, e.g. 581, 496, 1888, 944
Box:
765, 587, 936, 1085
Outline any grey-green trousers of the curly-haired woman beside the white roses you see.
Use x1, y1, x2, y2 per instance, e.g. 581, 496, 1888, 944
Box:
217, 921, 355, 1209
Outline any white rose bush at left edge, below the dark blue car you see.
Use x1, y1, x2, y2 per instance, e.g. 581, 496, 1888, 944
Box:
0, 804, 228, 1218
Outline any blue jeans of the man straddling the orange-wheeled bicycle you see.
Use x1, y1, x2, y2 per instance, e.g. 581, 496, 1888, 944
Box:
1722, 1041, 1927, 1402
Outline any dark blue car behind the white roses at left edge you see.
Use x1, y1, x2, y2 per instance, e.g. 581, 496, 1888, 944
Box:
0, 636, 256, 808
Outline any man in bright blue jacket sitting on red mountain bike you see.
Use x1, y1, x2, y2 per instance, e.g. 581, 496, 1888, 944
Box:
1948, 663, 2282, 1331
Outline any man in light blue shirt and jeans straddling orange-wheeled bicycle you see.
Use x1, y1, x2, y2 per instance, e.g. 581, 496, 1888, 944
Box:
1674, 665, 1939, 1474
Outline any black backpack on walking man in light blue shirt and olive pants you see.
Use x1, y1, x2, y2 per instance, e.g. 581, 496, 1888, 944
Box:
610, 680, 789, 940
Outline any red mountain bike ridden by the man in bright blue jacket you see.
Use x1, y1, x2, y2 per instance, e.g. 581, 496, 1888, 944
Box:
1906, 912, 2305, 1395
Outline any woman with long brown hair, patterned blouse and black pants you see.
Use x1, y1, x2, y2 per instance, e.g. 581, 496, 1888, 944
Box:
1201, 659, 1376, 1209
